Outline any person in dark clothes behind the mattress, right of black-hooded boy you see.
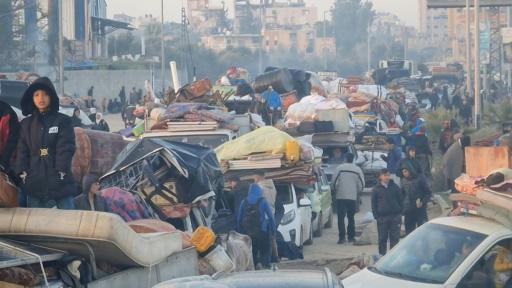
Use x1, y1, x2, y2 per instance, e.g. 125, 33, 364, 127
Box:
73, 174, 107, 211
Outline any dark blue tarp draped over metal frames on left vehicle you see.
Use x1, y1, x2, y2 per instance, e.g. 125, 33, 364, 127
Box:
105, 138, 224, 204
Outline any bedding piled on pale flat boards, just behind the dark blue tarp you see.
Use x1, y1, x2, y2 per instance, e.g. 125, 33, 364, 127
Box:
151, 103, 238, 132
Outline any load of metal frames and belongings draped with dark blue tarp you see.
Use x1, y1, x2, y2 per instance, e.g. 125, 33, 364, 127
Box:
100, 138, 224, 219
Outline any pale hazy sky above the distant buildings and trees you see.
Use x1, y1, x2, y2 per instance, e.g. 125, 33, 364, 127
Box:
107, 0, 418, 27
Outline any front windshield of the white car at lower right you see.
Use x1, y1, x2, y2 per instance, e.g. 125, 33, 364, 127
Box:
370, 223, 486, 284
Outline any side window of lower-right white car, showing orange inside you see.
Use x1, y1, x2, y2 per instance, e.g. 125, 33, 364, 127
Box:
457, 239, 512, 288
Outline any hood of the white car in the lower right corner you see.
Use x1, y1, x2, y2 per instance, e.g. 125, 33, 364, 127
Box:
343, 269, 443, 288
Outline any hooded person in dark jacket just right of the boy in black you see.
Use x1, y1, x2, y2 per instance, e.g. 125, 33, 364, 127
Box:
402, 167, 432, 235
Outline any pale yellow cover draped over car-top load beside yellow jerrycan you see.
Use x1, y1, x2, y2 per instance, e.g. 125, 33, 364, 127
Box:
215, 126, 294, 161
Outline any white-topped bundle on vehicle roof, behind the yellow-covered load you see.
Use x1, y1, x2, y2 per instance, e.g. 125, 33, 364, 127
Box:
285, 95, 352, 134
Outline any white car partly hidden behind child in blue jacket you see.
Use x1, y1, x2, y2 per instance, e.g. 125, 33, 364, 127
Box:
274, 182, 313, 247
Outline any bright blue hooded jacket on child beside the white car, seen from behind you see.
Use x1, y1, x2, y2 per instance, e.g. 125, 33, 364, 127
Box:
236, 183, 276, 235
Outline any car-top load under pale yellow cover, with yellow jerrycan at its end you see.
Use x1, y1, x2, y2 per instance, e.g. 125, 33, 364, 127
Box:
215, 126, 315, 170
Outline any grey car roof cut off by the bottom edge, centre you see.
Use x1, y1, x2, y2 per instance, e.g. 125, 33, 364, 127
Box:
153, 268, 343, 288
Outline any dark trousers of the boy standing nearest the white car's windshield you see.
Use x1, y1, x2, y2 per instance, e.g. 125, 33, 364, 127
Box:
377, 215, 402, 256
